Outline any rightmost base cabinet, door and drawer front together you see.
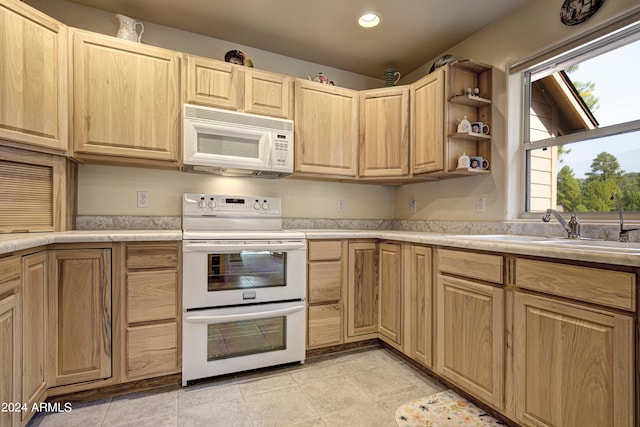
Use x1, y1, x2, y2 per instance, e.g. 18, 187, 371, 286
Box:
512, 259, 637, 427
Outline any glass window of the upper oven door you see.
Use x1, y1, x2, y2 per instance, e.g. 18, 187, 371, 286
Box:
207, 251, 287, 292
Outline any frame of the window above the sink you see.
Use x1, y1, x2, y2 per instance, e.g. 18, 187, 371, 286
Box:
518, 20, 640, 219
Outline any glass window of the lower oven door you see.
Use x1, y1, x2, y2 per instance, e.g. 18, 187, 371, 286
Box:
207, 316, 287, 362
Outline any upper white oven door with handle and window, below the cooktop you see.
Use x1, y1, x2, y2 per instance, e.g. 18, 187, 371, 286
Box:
182, 240, 307, 309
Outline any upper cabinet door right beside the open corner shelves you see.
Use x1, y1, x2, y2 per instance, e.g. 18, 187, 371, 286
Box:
410, 68, 445, 174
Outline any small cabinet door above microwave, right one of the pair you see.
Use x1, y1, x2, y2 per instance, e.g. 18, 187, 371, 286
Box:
244, 69, 293, 119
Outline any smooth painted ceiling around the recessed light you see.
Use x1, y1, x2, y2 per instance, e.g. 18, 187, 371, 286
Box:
63, 0, 531, 78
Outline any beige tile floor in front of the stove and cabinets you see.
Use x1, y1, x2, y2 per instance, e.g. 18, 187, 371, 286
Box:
28, 347, 446, 427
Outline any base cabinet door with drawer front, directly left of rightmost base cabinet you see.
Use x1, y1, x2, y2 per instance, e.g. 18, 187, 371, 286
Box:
435, 248, 505, 409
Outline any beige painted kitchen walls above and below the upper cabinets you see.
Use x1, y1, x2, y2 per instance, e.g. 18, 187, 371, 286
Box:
27, 0, 640, 221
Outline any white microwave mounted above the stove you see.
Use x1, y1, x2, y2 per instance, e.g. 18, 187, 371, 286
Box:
183, 104, 293, 178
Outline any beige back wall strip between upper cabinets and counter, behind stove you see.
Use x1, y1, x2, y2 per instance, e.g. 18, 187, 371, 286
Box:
78, 165, 394, 219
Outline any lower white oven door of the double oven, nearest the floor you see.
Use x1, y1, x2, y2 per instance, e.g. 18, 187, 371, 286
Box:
182, 301, 305, 385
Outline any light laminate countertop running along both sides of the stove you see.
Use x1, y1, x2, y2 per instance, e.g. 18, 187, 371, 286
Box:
0, 229, 640, 267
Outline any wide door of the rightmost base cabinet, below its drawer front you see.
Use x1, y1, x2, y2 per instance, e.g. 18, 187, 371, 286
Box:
513, 292, 637, 427
